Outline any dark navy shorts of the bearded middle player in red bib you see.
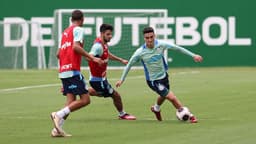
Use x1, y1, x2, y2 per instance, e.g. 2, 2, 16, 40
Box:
90, 80, 114, 97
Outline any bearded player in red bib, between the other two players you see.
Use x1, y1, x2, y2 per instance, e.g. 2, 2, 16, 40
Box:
89, 24, 136, 120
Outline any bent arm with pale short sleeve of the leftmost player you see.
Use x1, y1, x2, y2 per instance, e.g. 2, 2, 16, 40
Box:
73, 27, 104, 65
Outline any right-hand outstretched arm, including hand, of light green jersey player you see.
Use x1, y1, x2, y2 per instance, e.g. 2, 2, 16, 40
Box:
166, 40, 203, 62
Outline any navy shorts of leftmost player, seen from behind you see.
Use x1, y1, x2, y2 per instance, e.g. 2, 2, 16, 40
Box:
61, 74, 88, 95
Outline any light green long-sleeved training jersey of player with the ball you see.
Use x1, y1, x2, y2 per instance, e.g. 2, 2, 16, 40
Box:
121, 40, 195, 81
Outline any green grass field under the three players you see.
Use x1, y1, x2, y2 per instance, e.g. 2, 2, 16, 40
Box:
0, 67, 256, 144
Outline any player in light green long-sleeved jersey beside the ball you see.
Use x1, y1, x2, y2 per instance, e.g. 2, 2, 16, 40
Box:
116, 27, 203, 123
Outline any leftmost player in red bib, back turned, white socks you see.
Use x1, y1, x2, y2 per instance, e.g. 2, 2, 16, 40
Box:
51, 10, 104, 137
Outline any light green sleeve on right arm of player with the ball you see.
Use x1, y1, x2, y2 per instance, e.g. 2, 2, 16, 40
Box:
159, 41, 195, 57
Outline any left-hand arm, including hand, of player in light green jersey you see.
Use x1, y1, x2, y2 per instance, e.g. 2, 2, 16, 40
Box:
116, 49, 140, 87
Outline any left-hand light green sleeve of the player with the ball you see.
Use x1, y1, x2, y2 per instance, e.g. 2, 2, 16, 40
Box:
121, 48, 142, 81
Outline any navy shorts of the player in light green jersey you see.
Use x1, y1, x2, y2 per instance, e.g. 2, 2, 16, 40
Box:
147, 74, 170, 97
